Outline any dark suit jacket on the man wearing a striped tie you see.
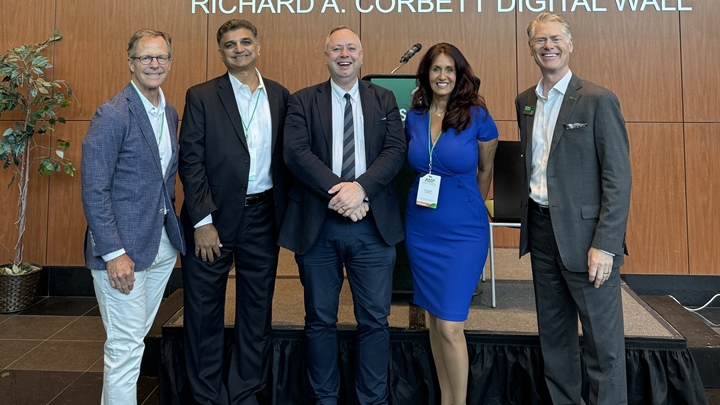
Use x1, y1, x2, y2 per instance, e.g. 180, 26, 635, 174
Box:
278, 80, 407, 254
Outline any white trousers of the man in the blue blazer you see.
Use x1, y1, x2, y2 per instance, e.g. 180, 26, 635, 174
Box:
92, 227, 177, 405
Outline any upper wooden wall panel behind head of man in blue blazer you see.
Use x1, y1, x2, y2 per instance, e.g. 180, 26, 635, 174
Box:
55, 0, 207, 120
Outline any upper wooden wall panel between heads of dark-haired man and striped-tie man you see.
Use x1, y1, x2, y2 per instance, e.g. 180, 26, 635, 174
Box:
207, 12, 360, 93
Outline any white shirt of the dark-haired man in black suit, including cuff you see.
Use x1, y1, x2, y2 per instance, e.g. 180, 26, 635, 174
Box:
195, 69, 273, 228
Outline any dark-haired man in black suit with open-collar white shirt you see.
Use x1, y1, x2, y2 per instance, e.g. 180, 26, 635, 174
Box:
179, 20, 291, 405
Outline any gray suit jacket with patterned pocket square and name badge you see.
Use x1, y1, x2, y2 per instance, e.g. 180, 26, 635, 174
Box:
515, 75, 632, 272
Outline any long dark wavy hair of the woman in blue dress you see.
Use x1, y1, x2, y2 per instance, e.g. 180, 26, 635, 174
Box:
412, 42, 488, 134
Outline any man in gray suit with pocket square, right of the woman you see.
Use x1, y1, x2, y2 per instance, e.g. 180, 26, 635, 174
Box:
515, 13, 631, 405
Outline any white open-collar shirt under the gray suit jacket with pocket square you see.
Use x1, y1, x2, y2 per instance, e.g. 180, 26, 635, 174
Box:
530, 70, 572, 205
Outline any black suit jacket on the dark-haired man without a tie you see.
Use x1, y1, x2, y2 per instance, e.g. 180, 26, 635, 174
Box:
178, 73, 292, 242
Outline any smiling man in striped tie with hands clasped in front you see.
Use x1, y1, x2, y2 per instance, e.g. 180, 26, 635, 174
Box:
278, 27, 406, 404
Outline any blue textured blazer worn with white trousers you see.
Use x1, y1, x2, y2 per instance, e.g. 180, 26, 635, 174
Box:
81, 84, 185, 271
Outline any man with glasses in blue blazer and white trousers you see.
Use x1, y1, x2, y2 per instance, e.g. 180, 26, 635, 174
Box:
82, 30, 185, 405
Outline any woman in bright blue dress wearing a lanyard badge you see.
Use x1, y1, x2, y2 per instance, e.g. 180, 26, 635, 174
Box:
405, 43, 498, 405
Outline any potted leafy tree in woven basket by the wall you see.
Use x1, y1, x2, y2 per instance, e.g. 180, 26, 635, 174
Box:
0, 30, 77, 313
